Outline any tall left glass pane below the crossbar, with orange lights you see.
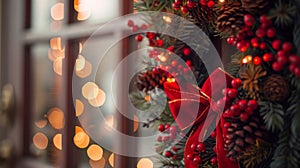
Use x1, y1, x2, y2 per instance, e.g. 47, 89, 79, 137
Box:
29, 40, 65, 165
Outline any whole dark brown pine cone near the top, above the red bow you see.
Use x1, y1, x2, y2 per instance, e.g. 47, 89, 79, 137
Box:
216, 2, 245, 36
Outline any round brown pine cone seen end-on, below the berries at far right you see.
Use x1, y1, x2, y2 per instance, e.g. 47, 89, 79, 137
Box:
262, 74, 290, 102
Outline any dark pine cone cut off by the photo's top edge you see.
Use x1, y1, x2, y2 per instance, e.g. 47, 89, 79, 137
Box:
241, 0, 269, 13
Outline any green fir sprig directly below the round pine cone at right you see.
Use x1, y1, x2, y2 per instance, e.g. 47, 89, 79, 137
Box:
259, 101, 284, 132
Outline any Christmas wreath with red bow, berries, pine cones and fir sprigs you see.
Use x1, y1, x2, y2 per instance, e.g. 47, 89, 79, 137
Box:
128, 0, 300, 168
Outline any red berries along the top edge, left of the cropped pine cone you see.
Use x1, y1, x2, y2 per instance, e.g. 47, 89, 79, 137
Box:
172, 0, 215, 14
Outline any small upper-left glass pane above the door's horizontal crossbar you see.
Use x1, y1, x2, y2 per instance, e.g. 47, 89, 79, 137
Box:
31, 0, 64, 31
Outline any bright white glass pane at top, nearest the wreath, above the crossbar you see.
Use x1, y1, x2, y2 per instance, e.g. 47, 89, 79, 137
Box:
74, 0, 121, 22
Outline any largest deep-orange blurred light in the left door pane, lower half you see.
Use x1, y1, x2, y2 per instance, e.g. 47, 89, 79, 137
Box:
48, 108, 65, 129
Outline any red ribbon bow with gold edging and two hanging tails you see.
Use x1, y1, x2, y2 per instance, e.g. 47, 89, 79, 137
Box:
164, 68, 239, 168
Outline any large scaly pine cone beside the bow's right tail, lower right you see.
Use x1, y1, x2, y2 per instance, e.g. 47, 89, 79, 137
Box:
225, 116, 265, 160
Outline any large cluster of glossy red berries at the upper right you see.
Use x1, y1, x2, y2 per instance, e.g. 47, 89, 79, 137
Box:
227, 14, 300, 76
